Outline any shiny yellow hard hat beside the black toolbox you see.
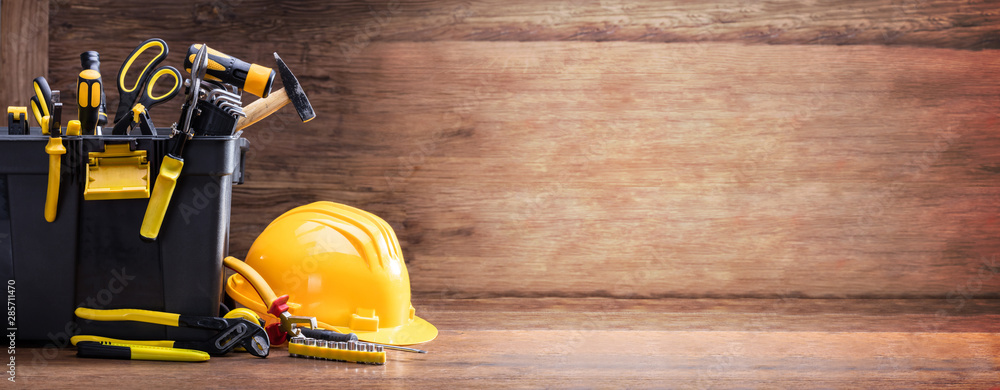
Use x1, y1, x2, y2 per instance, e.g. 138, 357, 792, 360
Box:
226, 202, 437, 345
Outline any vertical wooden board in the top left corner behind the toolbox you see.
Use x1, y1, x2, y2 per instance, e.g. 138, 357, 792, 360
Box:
0, 0, 49, 108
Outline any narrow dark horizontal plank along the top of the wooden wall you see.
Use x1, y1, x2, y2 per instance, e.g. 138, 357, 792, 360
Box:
47, 0, 1000, 48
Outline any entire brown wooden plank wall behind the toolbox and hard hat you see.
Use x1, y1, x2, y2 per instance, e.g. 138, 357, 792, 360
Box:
21, 0, 1000, 299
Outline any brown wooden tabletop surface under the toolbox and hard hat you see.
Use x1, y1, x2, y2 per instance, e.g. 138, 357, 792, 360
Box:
16, 298, 1000, 389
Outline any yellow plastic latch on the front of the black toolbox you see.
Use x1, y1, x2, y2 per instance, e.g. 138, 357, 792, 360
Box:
85, 145, 149, 200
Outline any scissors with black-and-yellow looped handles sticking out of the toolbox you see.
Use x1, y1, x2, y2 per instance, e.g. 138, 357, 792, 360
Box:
112, 38, 183, 135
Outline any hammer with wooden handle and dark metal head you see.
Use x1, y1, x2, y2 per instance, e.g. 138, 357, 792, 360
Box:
236, 53, 316, 131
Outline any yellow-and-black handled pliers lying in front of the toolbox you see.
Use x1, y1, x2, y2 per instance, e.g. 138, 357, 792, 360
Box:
70, 307, 270, 360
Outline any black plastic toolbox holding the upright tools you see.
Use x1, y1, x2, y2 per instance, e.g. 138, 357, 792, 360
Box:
0, 127, 249, 347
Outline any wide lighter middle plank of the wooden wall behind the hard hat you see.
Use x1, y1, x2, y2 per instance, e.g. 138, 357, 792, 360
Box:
234, 42, 1000, 297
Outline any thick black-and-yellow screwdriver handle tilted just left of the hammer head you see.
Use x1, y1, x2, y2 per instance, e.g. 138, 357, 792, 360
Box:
184, 43, 275, 98
